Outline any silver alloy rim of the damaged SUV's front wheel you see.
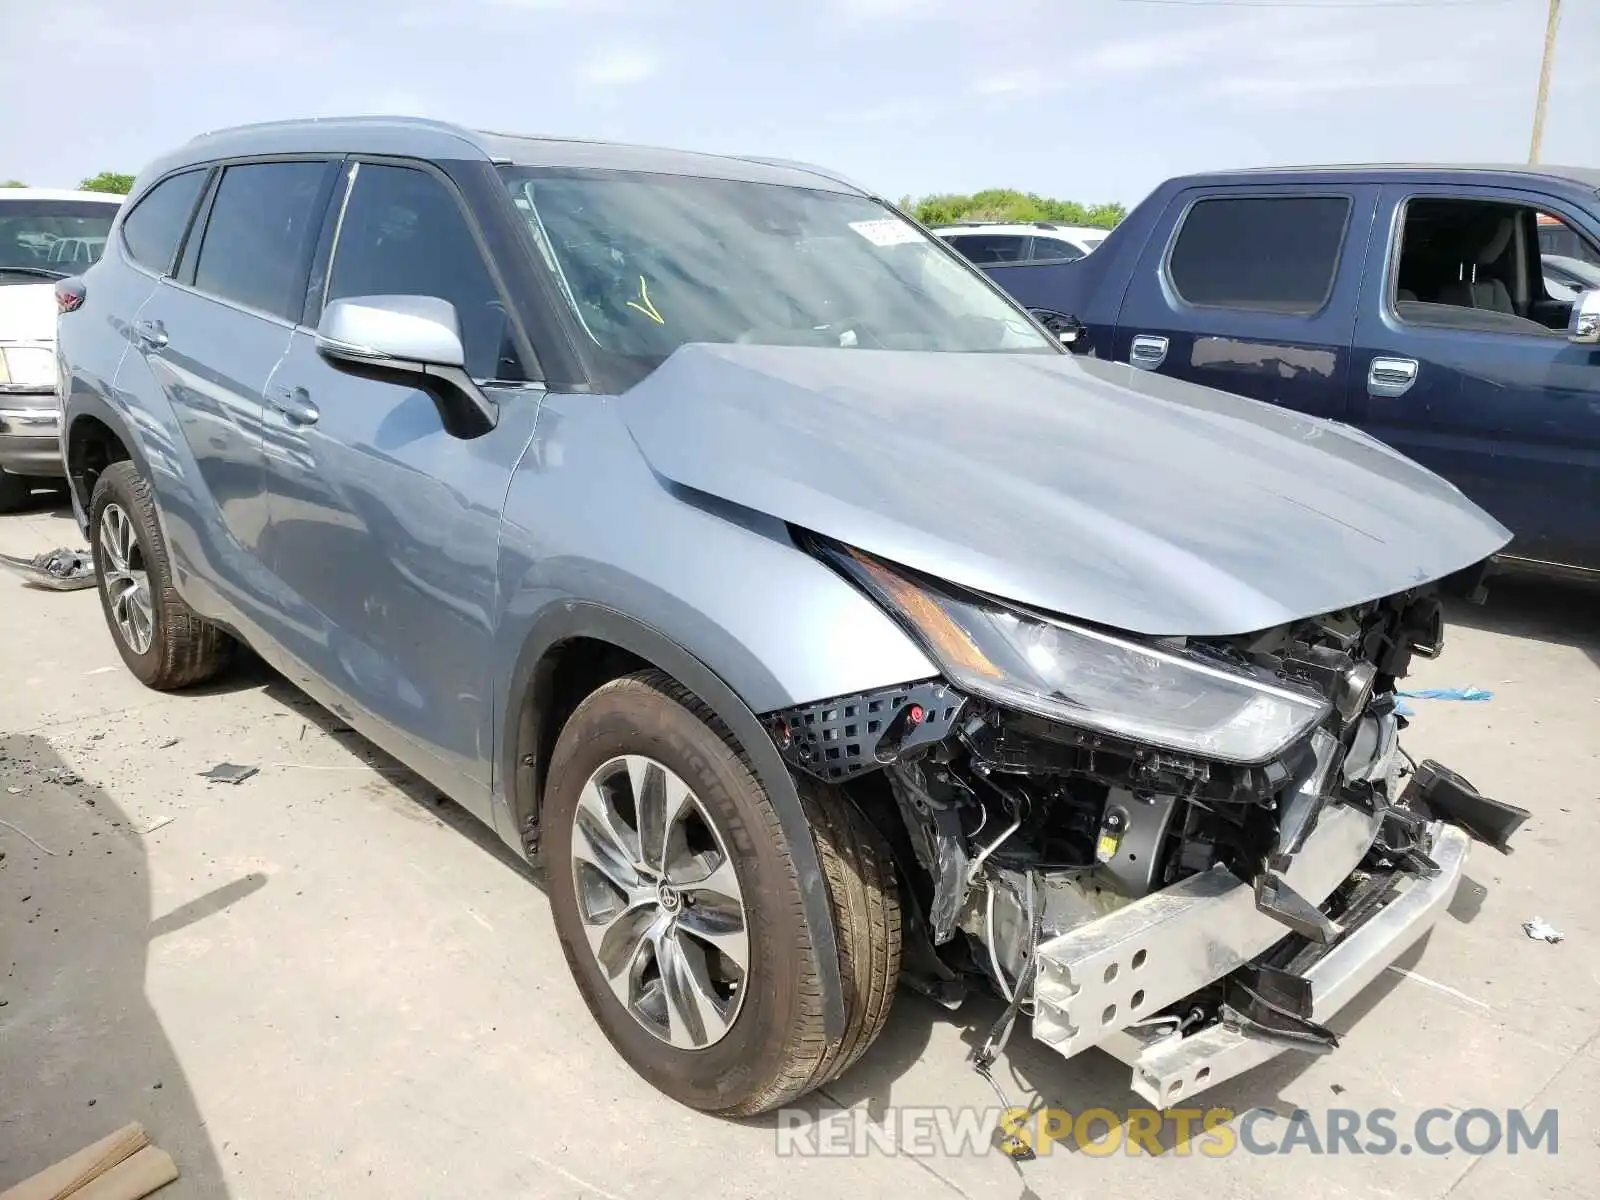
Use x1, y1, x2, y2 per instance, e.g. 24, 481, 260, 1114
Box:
571, 754, 750, 1050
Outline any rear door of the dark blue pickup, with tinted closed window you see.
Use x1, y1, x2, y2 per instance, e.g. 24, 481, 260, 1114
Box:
1110, 186, 1378, 419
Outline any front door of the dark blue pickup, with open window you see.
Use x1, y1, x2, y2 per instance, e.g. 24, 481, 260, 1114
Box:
1349, 184, 1600, 568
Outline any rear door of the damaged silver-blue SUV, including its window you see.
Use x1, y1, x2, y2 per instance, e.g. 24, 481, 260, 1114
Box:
118, 158, 333, 624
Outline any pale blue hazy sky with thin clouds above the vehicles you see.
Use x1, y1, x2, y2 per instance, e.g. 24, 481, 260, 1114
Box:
0, 0, 1600, 203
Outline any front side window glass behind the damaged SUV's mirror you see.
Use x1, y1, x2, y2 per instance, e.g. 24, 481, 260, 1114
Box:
328, 163, 526, 381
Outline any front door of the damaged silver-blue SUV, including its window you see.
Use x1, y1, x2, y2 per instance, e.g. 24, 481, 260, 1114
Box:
264, 162, 542, 819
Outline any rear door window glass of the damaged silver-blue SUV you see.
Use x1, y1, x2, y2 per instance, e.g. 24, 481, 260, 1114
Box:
195, 162, 330, 320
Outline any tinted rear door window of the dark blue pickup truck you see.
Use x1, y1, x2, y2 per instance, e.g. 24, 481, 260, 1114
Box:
1166, 195, 1350, 315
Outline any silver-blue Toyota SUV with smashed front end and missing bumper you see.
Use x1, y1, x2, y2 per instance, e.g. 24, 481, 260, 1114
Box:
56, 118, 1526, 1114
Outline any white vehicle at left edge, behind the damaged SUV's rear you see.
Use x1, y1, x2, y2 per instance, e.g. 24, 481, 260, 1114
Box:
0, 187, 122, 512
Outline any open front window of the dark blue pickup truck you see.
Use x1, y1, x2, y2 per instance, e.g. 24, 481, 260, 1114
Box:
1390, 195, 1594, 338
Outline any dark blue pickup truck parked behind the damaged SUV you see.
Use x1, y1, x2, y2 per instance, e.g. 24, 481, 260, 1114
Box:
984, 166, 1600, 579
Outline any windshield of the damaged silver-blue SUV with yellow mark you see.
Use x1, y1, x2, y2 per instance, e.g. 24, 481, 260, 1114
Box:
506, 168, 1056, 377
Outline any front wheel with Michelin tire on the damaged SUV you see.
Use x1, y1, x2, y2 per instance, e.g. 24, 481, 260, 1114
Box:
541, 672, 901, 1117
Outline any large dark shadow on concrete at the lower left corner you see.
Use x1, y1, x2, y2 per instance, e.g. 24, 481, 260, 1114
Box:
0, 734, 232, 1200
